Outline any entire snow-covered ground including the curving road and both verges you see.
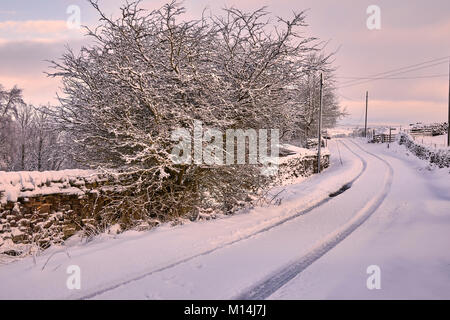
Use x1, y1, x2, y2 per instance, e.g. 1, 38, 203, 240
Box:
0, 139, 450, 299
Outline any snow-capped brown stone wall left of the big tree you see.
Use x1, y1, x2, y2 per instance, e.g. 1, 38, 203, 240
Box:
0, 170, 105, 254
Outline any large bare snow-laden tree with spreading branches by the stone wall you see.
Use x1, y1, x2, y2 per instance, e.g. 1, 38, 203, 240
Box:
50, 1, 340, 225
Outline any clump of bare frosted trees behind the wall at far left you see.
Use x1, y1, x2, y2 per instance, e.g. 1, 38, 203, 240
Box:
0, 85, 76, 171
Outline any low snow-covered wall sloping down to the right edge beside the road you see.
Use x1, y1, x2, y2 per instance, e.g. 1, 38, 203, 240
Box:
398, 133, 450, 168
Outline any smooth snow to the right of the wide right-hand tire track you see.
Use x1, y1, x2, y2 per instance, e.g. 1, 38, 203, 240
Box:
270, 141, 450, 299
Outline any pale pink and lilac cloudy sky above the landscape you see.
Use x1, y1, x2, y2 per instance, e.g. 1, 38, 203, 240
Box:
0, 0, 450, 123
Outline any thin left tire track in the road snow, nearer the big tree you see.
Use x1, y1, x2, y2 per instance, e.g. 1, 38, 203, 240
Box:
73, 140, 367, 300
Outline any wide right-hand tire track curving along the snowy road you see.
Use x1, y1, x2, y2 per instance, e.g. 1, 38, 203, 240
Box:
234, 141, 394, 300
